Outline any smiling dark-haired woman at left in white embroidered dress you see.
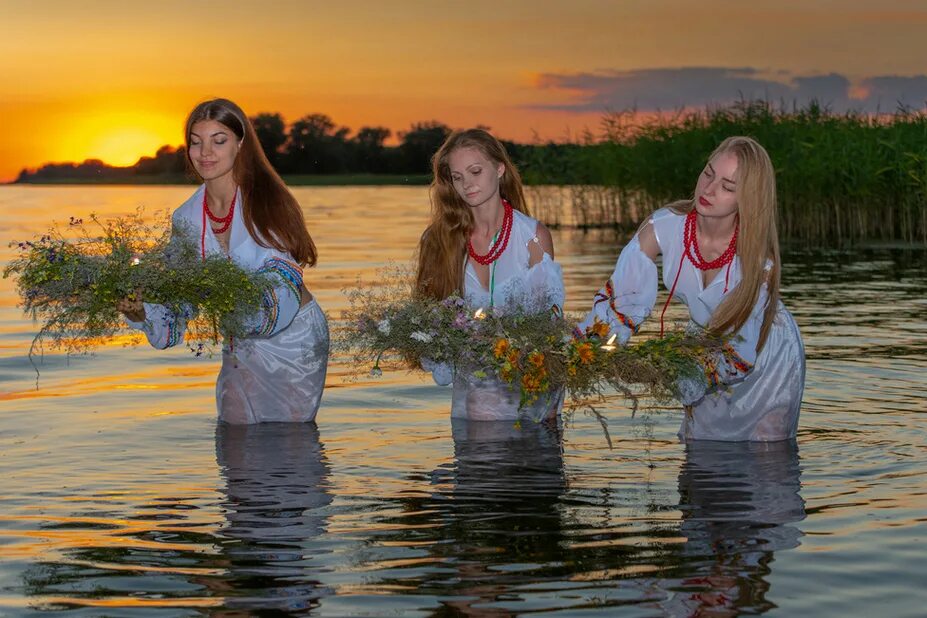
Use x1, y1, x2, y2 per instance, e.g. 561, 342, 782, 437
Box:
119, 99, 329, 424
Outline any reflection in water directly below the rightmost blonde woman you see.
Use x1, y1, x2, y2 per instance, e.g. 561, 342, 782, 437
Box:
661, 441, 805, 616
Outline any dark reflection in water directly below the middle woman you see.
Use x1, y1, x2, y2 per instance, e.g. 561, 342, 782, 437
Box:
440, 419, 566, 616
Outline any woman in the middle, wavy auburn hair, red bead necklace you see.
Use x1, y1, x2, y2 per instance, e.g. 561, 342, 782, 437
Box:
416, 129, 564, 420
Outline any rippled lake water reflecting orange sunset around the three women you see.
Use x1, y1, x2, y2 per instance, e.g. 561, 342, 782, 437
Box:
0, 187, 927, 616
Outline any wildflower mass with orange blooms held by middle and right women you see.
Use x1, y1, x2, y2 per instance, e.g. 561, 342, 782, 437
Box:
336, 271, 722, 408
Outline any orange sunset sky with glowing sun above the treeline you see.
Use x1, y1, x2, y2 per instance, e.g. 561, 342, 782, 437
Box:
0, 0, 927, 180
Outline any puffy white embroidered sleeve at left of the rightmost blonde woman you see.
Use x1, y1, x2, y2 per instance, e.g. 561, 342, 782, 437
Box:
576, 236, 657, 344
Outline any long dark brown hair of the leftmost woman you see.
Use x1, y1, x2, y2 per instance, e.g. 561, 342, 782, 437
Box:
184, 99, 318, 266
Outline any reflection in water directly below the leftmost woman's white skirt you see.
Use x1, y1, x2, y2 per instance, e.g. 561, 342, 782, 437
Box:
209, 423, 332, 611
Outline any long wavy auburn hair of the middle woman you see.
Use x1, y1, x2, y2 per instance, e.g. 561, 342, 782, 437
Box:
415, 129, 528, 299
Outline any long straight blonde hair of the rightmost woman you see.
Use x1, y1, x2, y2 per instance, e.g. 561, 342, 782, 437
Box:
670, 136, 781, 353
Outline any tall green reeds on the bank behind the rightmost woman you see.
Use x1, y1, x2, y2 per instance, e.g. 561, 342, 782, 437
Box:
520, 101, 927, 244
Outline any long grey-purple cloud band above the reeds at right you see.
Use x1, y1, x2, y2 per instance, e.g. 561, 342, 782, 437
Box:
538, 67, 927, 112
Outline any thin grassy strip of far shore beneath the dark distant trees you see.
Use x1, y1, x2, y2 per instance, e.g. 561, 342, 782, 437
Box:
4, 174, 431, 187
